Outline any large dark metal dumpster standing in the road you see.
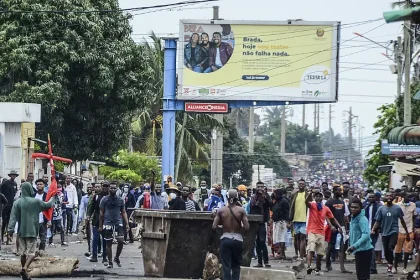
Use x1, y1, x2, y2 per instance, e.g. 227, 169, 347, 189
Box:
134, 209, 262, 279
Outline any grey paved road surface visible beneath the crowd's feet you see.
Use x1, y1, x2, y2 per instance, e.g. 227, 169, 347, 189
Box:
0, 236, 413, 280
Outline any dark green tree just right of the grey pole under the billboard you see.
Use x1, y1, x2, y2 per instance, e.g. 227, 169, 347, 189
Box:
223, 118, 252, 186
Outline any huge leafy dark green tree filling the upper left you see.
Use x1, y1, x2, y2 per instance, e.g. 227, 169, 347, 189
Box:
0, 0, 148, 160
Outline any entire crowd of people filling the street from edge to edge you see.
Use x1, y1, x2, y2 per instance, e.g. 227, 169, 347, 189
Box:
0, 168, 420, 280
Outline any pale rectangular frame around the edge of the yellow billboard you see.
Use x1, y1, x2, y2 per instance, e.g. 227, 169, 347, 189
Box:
175, 19, 341, 104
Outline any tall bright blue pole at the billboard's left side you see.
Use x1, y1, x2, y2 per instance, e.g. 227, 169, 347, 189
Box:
162, 38, 176, 185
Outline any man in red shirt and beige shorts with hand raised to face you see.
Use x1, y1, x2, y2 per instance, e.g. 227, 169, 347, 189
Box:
305, 189, 341, 275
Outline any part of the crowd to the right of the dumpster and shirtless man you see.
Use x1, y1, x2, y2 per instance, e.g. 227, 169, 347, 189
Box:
251, 179, 420, 280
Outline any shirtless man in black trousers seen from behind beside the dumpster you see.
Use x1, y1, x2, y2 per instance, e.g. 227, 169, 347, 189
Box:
213, 190, 249, 280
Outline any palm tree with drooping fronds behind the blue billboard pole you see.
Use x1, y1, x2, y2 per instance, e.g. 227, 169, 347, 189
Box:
132, 33, 223, 182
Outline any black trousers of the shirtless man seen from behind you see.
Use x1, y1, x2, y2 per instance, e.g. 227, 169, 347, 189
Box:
220, 238, 243, 280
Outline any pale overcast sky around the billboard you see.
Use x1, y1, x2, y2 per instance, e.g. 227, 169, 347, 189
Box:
119, 0, 402, 153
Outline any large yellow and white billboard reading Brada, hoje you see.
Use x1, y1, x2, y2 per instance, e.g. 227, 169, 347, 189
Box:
177, 20, 340, 102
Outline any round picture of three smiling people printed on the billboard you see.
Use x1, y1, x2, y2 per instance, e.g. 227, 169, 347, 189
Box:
184, 25, 234, 73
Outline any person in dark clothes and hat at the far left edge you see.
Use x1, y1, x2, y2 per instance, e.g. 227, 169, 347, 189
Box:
0, 171, 19, 243
